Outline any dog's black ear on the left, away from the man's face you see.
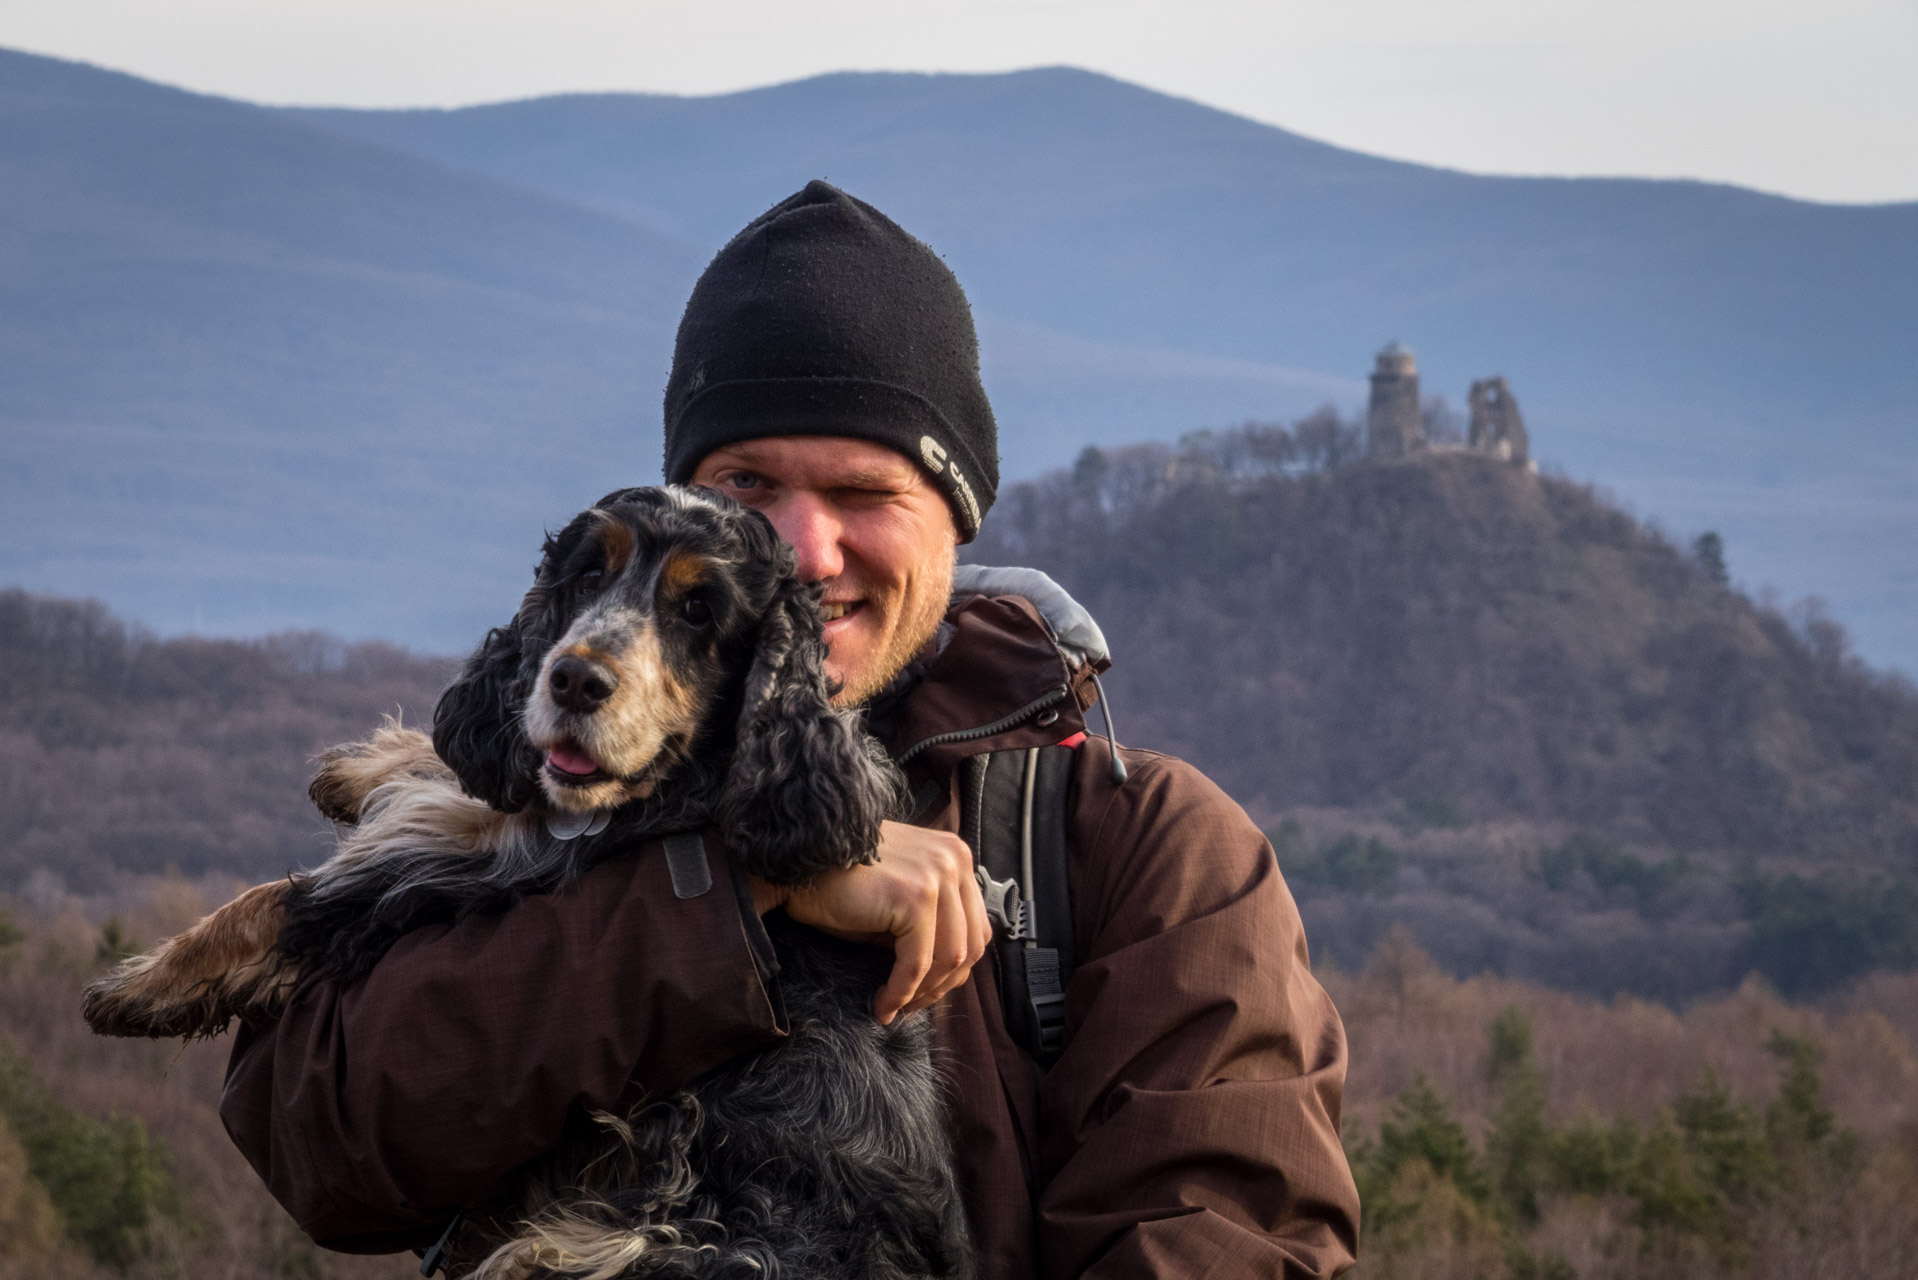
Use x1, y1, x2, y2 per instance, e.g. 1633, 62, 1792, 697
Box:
433, 579, 552, 814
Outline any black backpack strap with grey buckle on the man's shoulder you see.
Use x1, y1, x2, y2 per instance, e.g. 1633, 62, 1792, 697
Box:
959, 747, 1074, 1069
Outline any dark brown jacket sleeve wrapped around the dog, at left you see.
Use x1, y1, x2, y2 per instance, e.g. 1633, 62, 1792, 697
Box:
221, 842, 783, 1253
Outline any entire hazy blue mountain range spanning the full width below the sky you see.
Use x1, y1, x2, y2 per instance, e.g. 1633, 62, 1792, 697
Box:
0, 45, 1918, 670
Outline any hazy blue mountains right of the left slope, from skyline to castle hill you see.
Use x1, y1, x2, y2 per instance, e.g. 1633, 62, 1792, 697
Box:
283, 67, 1918, 672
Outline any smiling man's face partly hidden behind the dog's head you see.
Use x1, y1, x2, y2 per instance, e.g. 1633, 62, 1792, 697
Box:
692, 436, 959, 704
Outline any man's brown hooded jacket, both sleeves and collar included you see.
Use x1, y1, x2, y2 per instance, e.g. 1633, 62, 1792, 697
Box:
221, 599, 1358, 1280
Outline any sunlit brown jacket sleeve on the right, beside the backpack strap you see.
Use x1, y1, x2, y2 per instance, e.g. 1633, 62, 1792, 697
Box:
1040, 743, 1358, 1280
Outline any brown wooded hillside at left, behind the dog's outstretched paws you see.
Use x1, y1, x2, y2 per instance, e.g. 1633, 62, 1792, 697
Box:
0, 591, 451, 894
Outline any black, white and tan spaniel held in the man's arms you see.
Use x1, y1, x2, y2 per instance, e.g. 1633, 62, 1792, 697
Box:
82, 486, 972, 1280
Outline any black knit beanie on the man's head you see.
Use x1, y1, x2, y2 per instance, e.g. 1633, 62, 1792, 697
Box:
666, 182, 999, 541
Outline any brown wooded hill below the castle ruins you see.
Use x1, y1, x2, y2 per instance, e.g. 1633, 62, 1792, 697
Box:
969, 429, 1918, 998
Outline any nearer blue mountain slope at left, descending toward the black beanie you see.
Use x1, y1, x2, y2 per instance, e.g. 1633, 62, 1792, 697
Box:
0, 52, 702, 649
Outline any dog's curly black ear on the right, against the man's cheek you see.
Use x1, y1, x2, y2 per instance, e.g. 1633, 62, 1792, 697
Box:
719, 576, 905, 885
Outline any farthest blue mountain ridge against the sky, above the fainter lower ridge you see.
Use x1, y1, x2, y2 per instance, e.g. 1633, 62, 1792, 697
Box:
293, 67, 1918, 430
